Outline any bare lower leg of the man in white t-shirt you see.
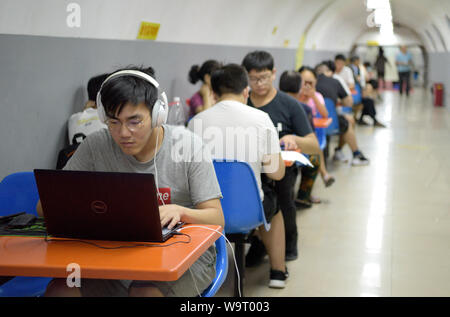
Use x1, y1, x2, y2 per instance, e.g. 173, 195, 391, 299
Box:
259, 212, 286, 272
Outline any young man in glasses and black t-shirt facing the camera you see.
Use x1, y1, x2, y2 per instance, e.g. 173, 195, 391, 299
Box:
242, 51, 320, 262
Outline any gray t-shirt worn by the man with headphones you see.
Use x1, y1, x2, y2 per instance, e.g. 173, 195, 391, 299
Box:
64, 125, 222, 208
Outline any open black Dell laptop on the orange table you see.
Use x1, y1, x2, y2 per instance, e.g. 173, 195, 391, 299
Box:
34, 169, 178, 242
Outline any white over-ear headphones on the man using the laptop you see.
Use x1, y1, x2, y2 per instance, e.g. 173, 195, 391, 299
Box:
97, 69, 169, 128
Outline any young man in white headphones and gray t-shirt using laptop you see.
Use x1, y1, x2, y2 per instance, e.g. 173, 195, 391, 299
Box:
38, 69, 224, 297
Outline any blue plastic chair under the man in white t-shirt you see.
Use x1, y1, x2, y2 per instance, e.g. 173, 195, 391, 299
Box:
213, 160, 270, 296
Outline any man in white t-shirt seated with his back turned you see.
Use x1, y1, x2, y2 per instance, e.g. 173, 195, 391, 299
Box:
188, 64, 287, 288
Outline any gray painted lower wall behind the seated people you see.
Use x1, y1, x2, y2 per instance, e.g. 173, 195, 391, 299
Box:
0, 34, 334, 179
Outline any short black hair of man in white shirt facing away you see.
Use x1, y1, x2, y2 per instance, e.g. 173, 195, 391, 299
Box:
211, 64, 248, 97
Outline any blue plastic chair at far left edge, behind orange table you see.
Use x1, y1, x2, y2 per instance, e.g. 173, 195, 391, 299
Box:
0, 172, 51, 297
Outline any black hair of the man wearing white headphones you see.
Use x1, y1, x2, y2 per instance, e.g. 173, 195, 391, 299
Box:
100, 67, 158, 118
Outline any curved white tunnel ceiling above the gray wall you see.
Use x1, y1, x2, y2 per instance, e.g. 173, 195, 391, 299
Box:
0, 0, 450, 52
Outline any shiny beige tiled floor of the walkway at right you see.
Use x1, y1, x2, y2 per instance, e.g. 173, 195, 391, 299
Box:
217, 89, 450, 297
